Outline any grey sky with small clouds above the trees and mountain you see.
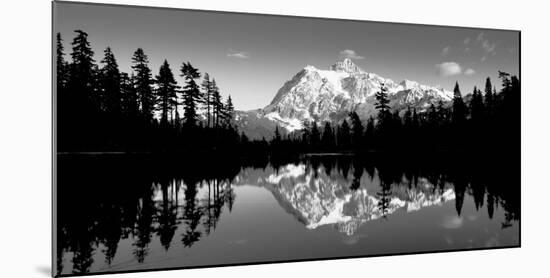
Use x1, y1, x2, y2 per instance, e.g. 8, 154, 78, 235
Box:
54, 2, 519, 110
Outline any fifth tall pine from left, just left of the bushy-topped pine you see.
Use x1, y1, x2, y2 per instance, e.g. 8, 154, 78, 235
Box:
155, 60, 178, 125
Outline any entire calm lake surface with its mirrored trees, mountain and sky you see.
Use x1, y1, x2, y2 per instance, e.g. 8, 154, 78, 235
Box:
56, 156, 520, 275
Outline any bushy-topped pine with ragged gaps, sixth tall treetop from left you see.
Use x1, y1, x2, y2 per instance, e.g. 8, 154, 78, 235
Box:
181, 62, 201, 127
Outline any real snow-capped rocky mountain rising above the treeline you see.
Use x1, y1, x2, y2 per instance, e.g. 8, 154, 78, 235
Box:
237, 58, 453, 137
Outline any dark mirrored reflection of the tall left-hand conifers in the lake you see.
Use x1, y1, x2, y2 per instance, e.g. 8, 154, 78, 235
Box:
56, 155, 240, 274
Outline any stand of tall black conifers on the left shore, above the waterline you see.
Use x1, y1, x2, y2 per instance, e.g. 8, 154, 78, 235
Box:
56, 30, 239, 152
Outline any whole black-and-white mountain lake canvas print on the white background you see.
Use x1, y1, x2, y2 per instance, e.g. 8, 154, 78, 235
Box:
52, 1, 520, 276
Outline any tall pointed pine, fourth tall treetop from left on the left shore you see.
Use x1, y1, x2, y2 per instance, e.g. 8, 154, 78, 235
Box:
132, 48, 156, 122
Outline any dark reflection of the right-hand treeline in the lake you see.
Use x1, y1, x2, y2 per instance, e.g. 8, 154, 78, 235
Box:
302, 153, 521, 223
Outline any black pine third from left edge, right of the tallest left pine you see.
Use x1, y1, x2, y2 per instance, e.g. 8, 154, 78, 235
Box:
101, 47, 122, 117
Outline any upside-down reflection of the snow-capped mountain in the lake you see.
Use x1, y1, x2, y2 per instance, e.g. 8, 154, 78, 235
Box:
238, 164, 455, 235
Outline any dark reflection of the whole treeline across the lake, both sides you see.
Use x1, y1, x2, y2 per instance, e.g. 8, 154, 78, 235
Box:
56, 154, 520, 274
